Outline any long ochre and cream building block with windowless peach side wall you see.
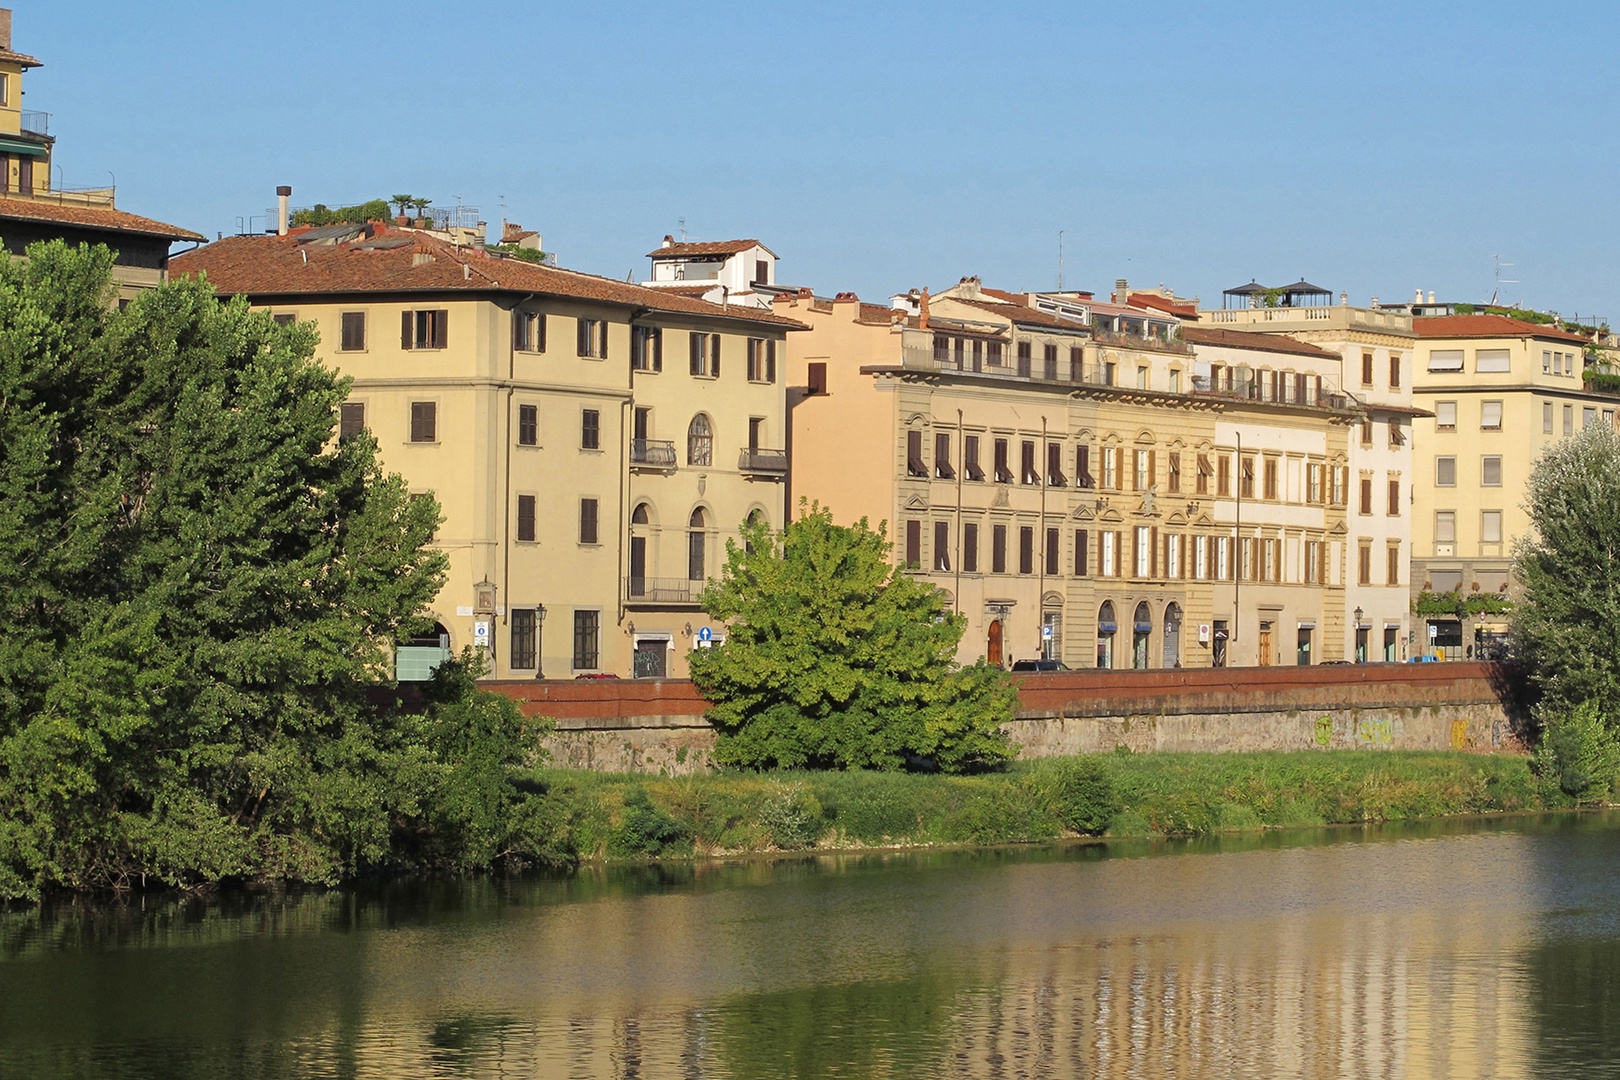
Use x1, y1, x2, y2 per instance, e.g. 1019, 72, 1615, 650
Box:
774, 279, 1359, 667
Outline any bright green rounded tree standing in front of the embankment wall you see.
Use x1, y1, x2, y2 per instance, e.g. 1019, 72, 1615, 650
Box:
692, 507, 1017, 772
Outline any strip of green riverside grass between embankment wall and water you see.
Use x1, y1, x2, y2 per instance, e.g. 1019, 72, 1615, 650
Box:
530, 750, 1547, 860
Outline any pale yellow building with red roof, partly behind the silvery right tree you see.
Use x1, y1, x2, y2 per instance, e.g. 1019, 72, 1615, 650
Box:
1411, 307, 1600, 661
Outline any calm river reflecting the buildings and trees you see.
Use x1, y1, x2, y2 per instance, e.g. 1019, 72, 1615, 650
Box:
0, 814, 1620, 1080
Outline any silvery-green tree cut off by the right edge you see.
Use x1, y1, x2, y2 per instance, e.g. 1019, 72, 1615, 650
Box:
1513, 424, 1620, 727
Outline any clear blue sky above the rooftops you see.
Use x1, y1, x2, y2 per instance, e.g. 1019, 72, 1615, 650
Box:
25, 0, 1620, 324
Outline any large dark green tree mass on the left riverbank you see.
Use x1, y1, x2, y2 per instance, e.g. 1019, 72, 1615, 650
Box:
0, 243, 560, 897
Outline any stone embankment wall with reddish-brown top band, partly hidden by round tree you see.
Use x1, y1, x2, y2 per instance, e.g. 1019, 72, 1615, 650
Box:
486, 664, 1524, 774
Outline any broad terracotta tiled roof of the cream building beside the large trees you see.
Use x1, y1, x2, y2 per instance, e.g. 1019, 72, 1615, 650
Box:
168, 223, 804, 329
